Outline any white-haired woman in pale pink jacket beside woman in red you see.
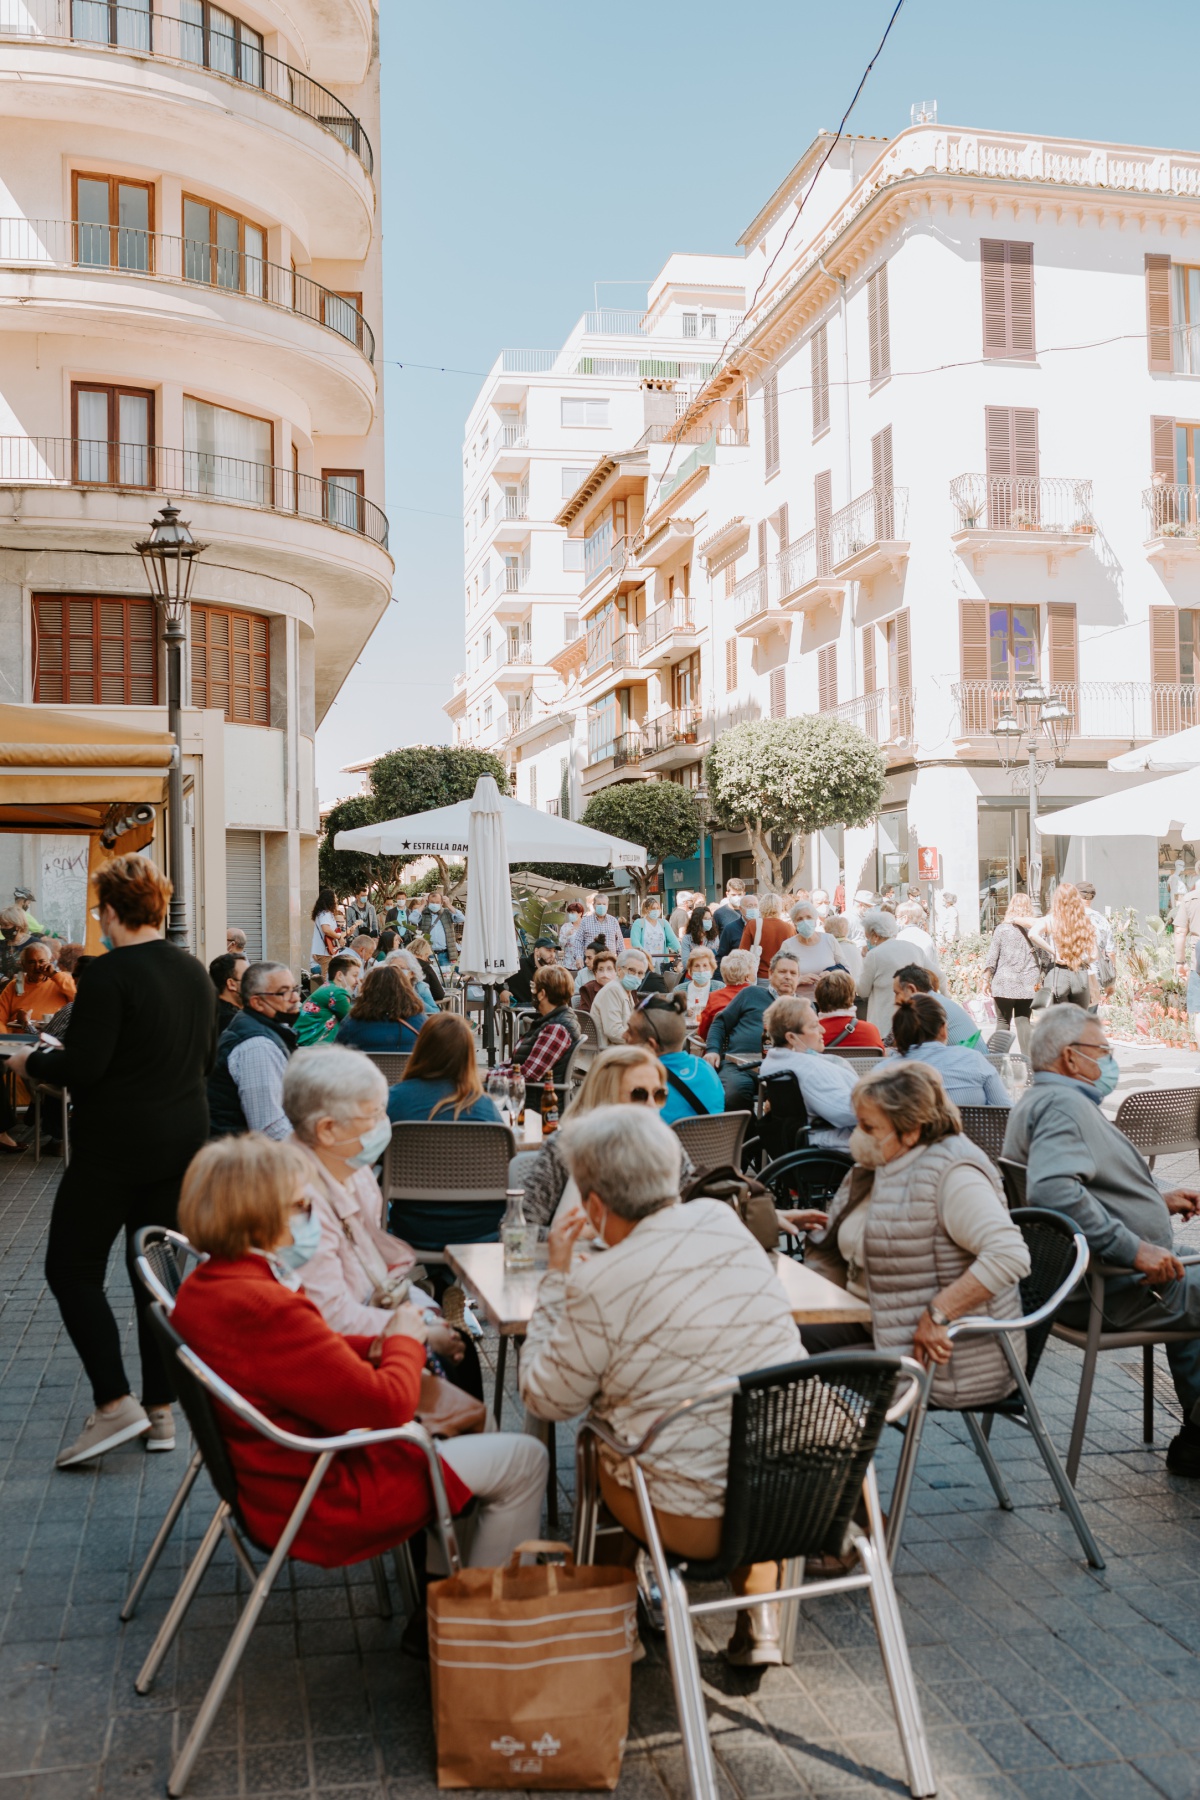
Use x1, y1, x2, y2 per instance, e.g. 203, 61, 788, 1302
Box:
282, 1044, 482, 1395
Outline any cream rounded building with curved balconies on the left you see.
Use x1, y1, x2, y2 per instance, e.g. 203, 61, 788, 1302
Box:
0, 0, 392, 959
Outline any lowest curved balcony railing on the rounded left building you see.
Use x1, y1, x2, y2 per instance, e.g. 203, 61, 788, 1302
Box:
0, 437, 387, 549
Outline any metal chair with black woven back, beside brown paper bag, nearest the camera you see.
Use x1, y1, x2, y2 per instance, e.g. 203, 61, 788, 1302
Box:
576, 1352, 937, 1800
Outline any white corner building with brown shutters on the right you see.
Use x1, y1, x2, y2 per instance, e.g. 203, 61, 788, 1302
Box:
449, 124, 1200, 931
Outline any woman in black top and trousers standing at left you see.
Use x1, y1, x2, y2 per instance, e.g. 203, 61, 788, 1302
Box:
9, 857, 216, 1469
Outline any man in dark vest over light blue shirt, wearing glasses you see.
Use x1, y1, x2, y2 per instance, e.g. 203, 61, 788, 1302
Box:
209, 963, 300, 1138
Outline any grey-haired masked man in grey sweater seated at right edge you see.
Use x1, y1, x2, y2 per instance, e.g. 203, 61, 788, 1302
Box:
1004, 1004, 1200, 1480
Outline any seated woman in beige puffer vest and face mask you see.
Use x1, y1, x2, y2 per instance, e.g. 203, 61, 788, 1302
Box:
806, 1062, 1029, 1408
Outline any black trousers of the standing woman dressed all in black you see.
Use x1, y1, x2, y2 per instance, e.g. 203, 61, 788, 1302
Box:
45, 1150, 195, 1406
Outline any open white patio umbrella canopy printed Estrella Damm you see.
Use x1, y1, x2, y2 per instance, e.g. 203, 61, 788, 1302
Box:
333, 792, 646, 875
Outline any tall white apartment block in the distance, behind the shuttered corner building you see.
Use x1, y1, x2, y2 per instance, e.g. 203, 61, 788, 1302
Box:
446, 256, 745, 817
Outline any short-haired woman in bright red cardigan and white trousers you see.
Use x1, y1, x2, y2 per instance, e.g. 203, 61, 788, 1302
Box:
171, 1134, 547, 1568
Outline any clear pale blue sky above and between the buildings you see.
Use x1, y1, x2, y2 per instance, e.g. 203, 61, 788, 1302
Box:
317, 0, 1200, 801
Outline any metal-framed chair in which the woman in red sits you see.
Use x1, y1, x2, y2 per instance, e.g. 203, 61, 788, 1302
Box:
135, 1303, 461, 1796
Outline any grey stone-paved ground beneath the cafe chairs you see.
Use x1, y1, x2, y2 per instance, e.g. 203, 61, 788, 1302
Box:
0, 1137, 1200, 1800
